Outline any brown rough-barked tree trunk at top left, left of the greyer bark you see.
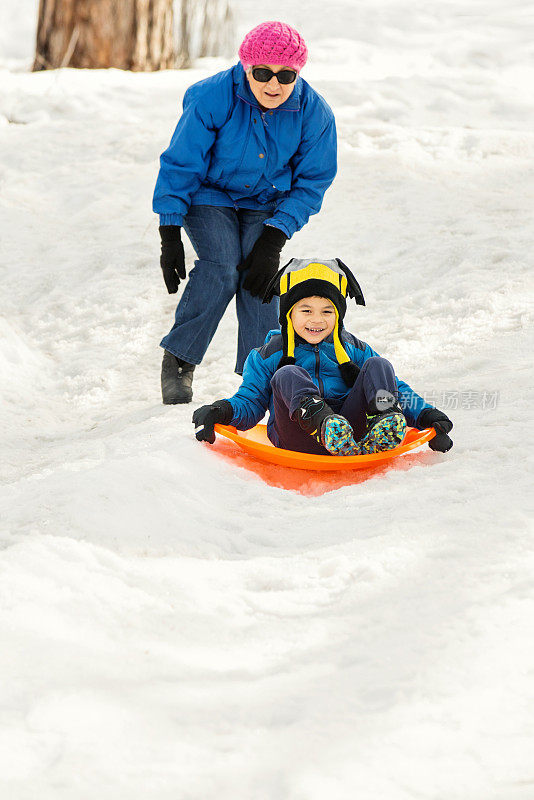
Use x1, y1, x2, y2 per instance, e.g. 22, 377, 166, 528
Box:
33, 0, 174, 71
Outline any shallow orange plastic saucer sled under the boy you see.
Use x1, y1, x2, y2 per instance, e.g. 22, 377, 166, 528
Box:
215, 425, 436, 472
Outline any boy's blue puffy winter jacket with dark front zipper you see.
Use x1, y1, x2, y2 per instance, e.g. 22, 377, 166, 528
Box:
227, 330, 432, 433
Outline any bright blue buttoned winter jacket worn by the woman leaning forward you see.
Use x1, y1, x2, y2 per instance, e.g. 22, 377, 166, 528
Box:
153, 64, 337, 237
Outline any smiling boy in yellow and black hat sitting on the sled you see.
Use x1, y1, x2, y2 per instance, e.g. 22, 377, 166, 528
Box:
193, 258, 452, 455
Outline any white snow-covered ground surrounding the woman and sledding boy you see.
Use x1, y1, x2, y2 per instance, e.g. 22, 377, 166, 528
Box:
0, 0, 534, 800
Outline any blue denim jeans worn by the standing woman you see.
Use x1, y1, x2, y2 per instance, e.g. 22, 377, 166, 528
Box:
161, 206, 279, 375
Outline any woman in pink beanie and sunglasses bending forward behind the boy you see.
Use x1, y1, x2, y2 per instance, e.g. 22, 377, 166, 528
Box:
153, 22, 336, 404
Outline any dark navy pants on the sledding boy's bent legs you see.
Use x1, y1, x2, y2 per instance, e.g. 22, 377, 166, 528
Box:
269, 356, 397, 456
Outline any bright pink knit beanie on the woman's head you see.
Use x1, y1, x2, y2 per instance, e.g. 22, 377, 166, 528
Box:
239, 22, 308, 72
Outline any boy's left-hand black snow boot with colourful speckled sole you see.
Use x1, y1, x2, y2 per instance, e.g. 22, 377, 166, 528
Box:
296, 395, 357, 456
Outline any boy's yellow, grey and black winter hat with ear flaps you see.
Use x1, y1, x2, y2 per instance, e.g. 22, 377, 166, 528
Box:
263, 258, 365, 386
